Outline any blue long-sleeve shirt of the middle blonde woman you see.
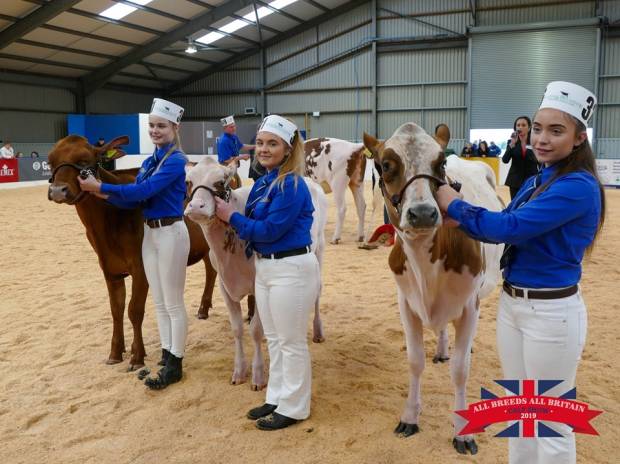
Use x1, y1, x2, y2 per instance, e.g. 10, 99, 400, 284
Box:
230, 169, 314, 254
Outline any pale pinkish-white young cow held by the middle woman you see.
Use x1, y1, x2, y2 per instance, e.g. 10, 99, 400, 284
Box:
185, 158, 327, 390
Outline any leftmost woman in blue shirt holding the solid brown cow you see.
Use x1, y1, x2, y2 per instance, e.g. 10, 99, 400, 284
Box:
78, 98, 189, 390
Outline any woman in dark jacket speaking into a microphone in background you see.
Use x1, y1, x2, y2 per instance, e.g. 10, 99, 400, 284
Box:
502, 116, 538, 199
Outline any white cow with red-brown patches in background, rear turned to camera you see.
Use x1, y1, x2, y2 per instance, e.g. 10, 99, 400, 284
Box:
304, 138, 366, 244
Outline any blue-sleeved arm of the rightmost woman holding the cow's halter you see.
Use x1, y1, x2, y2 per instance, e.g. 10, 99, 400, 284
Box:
437, 175, 597, 245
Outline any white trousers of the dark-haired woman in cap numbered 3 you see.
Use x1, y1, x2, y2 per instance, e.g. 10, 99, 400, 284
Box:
497, 291, 588, 464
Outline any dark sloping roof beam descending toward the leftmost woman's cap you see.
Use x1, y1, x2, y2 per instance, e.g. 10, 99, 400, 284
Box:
166, 0, 370, 94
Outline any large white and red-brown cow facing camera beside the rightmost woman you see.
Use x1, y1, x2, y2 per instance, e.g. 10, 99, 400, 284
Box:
364, 123, 502, 454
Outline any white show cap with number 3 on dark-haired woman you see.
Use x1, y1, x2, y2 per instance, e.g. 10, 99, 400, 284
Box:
540, 81, 596, 125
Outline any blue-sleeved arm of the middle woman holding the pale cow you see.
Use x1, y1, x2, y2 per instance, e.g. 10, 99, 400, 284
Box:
225, 176, 310, 243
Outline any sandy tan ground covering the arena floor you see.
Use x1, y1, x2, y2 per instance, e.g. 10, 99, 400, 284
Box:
0, 183, 620, 464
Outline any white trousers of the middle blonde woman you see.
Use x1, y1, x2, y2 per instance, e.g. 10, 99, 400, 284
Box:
255, 253, 320, 419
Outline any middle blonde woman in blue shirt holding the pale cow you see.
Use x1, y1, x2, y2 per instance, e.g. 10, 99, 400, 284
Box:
215, 115, 320, 430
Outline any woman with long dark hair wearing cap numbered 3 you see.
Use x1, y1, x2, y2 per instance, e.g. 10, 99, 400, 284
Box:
437, 82, 605, 464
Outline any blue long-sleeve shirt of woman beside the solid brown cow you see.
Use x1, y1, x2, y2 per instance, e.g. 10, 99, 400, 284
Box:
101, 144, 187, 219
